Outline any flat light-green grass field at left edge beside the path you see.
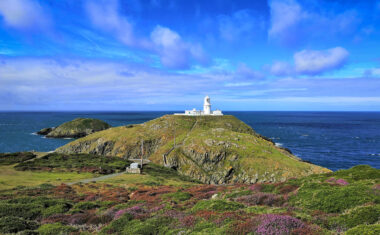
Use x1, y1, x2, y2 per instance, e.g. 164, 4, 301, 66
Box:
0, 165, 96, 190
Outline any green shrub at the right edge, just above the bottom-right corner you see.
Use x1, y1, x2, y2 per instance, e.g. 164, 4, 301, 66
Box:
330, 205, 380, 228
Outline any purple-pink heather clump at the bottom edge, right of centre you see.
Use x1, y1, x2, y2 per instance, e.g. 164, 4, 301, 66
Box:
256, 214, 305, 235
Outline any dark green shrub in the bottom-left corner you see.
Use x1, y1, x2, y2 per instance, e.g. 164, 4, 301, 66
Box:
0, 216, 38, 234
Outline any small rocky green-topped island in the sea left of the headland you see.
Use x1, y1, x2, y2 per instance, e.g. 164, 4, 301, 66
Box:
37, 118, 111, 138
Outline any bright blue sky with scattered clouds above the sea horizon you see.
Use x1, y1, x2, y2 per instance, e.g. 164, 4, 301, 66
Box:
0, 0, 380, 111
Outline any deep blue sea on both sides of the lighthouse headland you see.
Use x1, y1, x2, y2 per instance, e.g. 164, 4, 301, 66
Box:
0, 111, 380, 170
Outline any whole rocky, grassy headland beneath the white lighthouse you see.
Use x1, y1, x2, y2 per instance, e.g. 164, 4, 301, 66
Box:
56, 115, 330, 184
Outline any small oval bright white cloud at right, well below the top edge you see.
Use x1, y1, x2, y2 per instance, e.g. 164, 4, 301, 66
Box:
294, 47, 349, 75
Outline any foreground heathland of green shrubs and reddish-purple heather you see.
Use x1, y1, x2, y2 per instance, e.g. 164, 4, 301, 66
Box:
0, 164, 380, 235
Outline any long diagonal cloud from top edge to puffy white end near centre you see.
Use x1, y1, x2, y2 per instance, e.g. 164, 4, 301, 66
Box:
85, 0, 207, 69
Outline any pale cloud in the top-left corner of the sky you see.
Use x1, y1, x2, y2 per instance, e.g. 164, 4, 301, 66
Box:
0, 0, 51, 30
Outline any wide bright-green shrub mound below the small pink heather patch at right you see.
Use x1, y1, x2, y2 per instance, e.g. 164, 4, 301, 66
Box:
290, 183, 378, 213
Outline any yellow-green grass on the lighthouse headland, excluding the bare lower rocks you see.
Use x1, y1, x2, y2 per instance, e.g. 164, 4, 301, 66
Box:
58, 115, 329, 184
